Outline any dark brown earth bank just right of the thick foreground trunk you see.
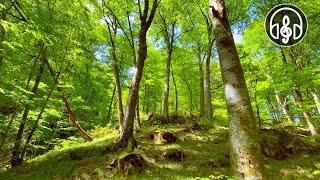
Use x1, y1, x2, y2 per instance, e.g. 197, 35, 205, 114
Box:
260, 129, 319, 160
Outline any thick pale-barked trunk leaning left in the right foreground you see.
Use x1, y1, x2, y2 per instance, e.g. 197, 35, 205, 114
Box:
210, 0, 265, 179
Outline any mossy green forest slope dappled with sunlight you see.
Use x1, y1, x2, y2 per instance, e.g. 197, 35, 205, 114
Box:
0, 120, 320, 180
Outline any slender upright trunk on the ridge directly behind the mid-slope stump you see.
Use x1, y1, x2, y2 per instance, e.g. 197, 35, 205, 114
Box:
162, 45, 173, 122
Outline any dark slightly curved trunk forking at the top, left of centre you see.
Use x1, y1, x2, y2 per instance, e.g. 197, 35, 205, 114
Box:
117, 0, 160, 148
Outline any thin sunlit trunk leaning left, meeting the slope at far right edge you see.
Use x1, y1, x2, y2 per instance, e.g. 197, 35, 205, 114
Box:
294, 89, 319, 136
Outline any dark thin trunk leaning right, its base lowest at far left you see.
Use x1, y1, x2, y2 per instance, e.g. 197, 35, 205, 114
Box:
11, 58, 45, 167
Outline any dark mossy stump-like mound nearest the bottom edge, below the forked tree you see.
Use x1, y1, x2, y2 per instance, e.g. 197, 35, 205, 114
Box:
114, 154, 146, 175
